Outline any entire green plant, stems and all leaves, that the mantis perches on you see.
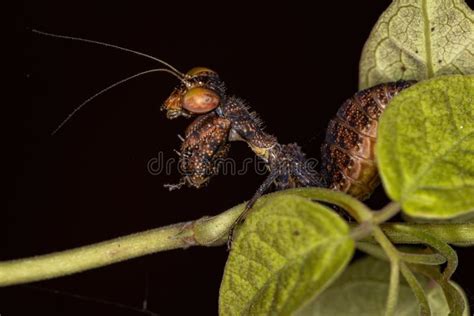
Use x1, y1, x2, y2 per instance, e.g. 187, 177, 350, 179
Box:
0, 0, 474, 315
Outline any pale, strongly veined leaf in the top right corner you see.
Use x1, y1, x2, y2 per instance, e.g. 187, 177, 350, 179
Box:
359, 0, 474, 89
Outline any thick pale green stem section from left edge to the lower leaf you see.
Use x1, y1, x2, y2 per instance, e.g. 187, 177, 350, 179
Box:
0, 204, 244, 286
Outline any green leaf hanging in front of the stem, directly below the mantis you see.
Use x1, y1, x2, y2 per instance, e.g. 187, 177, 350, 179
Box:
219, 195, 354, 315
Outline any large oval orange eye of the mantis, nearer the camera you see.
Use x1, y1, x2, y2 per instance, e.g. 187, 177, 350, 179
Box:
183, 87, 220, 114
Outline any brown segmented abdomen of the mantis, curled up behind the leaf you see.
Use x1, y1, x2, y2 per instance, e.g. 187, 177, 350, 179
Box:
321, 81, 414, 199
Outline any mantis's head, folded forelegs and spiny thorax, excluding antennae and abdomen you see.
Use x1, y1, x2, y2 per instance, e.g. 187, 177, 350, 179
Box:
162, 67, 322, 230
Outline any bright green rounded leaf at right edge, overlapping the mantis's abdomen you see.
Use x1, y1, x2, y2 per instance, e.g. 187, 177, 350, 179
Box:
376, 76, 474, 219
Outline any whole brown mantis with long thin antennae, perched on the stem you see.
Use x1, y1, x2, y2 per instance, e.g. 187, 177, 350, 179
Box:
33, 30, 414, 244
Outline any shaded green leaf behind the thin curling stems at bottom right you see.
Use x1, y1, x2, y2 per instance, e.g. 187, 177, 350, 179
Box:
297, 257, 469, 316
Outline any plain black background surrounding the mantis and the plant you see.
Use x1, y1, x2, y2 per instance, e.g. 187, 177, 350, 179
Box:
4, 0, 474, 316
